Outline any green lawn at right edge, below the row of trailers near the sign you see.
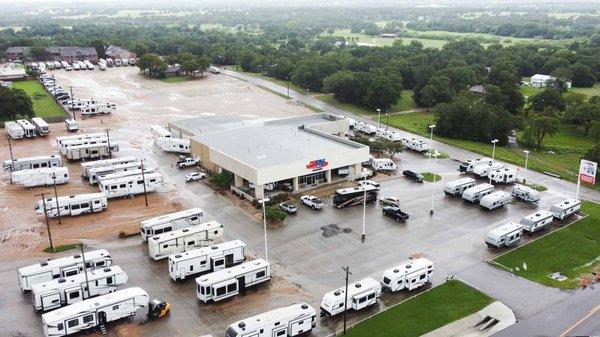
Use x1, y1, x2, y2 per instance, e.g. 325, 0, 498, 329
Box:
493, 201, 600, 289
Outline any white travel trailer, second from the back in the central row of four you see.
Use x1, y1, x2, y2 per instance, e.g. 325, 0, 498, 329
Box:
148, 221, 223, 261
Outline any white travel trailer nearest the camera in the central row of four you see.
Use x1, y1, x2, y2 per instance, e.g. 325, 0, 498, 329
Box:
196, 259, 271, 303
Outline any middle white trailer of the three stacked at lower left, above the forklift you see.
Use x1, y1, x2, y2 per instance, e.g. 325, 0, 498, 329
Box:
31, 266, 127, 311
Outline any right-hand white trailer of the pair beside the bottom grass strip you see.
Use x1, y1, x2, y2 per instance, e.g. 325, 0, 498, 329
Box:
381, 258, 433, 292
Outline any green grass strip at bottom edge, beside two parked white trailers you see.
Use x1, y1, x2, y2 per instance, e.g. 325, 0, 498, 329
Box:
346, 280, 493, 337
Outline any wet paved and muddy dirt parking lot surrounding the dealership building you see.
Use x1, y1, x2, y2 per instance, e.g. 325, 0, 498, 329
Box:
0, 68, 563, 337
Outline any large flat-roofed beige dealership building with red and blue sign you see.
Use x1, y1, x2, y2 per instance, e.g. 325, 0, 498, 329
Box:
169, 113, 369, 198
